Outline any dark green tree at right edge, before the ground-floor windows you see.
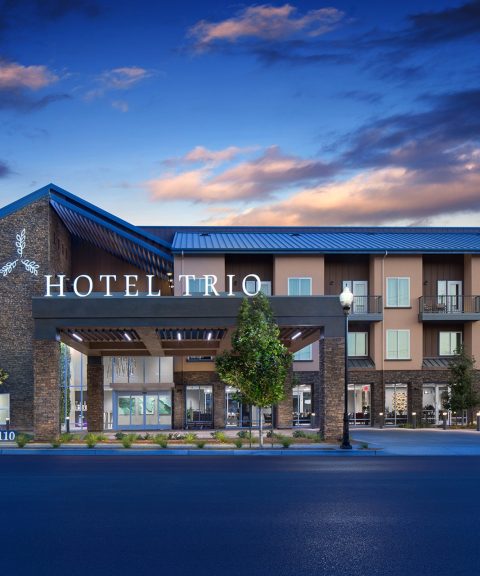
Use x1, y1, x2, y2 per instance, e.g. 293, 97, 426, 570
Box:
446, 345, 480, 426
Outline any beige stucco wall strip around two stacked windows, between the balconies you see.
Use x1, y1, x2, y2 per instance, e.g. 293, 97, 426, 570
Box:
377, 256, 423, 370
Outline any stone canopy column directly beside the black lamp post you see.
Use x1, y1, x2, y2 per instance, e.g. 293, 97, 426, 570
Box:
316, 338, 345, 441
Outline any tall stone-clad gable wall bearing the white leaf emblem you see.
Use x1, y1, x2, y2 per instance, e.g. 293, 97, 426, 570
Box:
0, 197, 70, 431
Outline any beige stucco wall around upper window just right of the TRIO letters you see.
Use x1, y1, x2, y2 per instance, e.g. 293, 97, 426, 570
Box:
273, 255, 325, 296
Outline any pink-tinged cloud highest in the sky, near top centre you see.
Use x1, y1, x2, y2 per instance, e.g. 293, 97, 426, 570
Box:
189, 4, 343, 50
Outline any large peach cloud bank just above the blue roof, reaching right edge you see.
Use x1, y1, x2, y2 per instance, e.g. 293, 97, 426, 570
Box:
208, 162, 480, 226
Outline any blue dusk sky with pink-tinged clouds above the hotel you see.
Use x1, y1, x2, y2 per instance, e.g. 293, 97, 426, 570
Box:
0, 0, 480, 226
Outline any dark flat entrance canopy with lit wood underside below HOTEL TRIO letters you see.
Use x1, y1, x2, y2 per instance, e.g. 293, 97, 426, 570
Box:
33, 295, 344, 356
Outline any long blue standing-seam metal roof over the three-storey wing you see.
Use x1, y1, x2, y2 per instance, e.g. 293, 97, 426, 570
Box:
172, 227, 480, 254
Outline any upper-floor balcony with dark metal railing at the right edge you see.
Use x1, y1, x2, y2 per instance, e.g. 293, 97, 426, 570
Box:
418, 296, 480, 322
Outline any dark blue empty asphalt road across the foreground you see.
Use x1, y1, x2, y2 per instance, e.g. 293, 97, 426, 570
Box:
0, 455, 480, 576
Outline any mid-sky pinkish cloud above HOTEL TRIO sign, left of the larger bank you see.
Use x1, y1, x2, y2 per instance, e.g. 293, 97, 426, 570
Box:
144, 146, 337, 202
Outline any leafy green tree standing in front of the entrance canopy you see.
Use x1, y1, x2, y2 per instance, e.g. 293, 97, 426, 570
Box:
216, 293, 292, 447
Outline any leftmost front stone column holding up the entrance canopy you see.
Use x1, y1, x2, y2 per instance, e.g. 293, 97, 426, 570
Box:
33, 340, 60, 440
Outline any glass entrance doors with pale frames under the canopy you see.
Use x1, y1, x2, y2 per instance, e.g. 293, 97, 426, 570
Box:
113, 390, 172, 429
